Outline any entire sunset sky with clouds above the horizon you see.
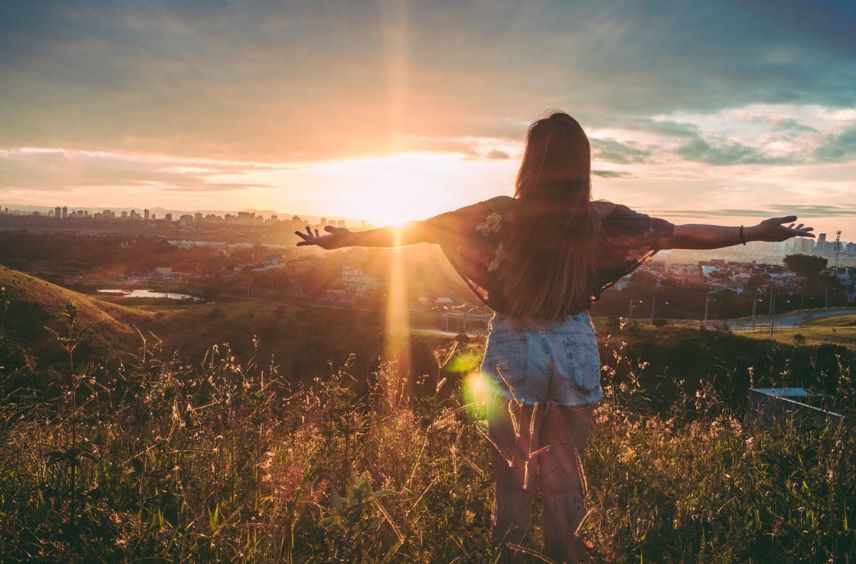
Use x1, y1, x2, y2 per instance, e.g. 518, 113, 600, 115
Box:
0, 0, 856, 235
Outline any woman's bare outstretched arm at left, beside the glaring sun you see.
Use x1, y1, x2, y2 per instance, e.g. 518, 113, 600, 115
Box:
294, 221, 429, 249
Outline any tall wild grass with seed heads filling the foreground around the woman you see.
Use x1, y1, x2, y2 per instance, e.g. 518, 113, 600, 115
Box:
0, 306, 856, 562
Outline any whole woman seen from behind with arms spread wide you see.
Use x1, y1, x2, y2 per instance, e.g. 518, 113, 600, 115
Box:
297, 113, 813, 561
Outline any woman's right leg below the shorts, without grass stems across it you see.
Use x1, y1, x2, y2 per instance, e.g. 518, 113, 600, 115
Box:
536, 403, 594, 562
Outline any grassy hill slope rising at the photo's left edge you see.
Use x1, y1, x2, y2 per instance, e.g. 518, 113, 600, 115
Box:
0, 266, 154, 369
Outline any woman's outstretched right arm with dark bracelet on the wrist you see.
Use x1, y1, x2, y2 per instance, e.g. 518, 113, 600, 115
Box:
660, 215, 814, 249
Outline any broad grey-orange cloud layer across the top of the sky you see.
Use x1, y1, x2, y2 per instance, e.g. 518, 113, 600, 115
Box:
0, 0, 856, 162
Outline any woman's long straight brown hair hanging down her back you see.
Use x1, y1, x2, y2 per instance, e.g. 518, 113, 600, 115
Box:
504, 112, 595, 321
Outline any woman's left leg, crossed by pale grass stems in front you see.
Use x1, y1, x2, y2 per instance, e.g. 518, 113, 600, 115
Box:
488, 397, 538, 562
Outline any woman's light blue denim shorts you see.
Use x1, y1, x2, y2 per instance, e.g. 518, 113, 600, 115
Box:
481, 312, 603, 406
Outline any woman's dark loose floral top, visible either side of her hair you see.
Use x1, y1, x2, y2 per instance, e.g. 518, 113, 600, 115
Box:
423, 196, 675, 313
